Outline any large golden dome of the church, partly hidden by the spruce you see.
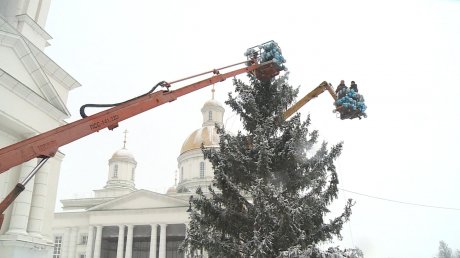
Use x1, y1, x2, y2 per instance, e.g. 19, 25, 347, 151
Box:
180, 125, 219, 154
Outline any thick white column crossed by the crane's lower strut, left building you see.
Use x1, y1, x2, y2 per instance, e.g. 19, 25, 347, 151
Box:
6, 159, 37, 235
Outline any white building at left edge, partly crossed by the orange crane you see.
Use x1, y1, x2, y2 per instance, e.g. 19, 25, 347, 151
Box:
0, 0, 80, 258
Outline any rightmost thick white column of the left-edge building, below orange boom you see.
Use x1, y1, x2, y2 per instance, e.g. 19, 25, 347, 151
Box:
27, 163, 50, 238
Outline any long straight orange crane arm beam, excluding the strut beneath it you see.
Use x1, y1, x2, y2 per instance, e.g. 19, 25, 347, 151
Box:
0, 61, 277, 173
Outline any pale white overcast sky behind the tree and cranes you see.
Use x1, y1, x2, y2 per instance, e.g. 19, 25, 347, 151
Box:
46, 0, 460, 258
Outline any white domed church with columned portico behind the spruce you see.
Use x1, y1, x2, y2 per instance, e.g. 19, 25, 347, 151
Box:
52, 96, 224, 258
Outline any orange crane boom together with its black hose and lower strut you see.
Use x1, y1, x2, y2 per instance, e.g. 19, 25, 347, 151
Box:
0, 58, 280, 227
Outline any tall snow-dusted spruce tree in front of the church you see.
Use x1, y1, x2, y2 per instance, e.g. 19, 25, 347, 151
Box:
182, 74, 352, 257
